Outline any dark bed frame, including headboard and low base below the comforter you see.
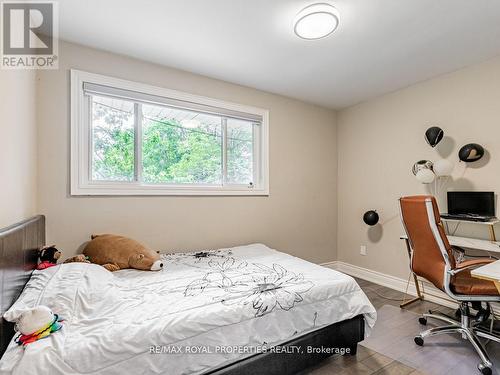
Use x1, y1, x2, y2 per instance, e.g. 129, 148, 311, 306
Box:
0, 215, 365, 375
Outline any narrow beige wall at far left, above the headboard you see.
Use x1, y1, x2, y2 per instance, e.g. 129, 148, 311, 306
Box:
0, 70, 37, 228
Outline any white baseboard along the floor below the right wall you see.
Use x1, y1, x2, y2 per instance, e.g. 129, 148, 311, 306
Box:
321, 261, 458, 309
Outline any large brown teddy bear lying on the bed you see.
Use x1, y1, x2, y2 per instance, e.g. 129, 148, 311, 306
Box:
83, 234, 163, 272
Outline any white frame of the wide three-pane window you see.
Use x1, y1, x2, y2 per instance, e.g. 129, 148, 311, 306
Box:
70, 69, 269, 196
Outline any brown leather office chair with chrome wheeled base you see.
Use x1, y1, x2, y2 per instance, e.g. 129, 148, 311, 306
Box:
399, 195, 500, 375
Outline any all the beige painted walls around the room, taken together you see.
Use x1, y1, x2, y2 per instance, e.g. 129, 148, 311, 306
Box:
7, 43, 500, 277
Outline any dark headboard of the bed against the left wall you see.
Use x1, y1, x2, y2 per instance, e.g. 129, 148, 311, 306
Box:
0, 215, 45, 356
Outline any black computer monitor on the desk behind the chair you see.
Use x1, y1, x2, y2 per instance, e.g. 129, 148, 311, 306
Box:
448, 191, 495, 217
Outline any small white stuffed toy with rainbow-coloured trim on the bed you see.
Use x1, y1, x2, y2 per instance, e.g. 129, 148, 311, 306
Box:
15, 305, 63, 346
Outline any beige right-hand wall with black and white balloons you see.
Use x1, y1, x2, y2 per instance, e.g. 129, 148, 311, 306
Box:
337, 58, 500, 278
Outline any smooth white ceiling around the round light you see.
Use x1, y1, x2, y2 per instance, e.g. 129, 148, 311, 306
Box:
59, 0, 500, 108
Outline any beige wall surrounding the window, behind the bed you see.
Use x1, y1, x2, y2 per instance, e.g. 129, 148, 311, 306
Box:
37, 43, 337, 262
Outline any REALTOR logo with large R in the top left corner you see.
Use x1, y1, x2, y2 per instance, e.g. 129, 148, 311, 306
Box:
1, 1, 58, 69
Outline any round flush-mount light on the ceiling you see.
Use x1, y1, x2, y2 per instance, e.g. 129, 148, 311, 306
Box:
293, 3, 340, 40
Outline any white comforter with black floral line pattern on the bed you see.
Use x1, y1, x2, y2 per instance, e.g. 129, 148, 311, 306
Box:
0, 244, 376, 375
